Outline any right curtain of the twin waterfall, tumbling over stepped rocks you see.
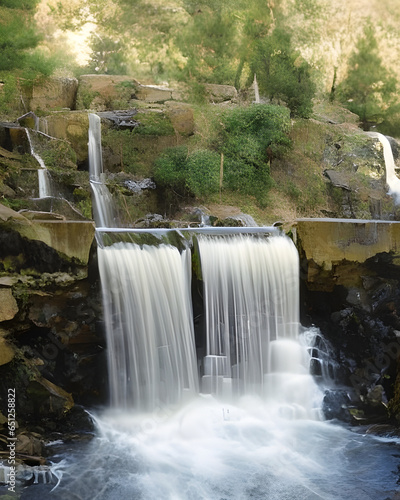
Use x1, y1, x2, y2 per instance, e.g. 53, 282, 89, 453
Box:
198, 235, 314, 417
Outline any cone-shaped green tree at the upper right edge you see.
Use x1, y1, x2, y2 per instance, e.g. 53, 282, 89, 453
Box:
337, 21, 398, 130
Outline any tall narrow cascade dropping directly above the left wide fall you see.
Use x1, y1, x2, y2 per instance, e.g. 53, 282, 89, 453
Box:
88, 113, 116, 227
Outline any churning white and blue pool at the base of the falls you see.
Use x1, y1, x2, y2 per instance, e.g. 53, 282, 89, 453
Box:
14, 397, 400, 500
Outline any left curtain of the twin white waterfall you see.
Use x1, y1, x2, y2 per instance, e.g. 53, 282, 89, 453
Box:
98, 243, 198, 410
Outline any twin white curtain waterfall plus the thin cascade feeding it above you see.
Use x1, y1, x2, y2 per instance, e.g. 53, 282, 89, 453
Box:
90, 115, 315, 418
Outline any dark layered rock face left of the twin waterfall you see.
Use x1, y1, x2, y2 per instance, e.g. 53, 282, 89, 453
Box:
0, 213, 106, 440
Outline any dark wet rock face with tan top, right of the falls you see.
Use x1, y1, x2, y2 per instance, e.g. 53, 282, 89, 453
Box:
297, 219, 400, 423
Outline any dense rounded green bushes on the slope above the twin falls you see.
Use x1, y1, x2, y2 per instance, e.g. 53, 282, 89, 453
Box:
154, 104, 290, 206
